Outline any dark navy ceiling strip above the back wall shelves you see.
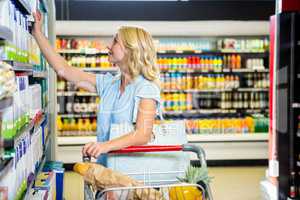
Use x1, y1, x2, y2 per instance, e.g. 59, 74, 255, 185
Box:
55, 0, 275, 21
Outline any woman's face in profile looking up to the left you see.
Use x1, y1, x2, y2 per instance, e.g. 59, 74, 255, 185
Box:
107, 34, 125, 64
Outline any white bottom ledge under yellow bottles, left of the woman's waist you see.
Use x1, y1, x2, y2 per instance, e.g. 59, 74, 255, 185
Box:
57, 136, 97, 146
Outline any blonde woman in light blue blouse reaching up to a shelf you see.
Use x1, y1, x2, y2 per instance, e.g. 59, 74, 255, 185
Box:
32, 13, 160, 166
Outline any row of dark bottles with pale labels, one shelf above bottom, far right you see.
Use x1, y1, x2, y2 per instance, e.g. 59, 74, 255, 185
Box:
196, 92, 268, 110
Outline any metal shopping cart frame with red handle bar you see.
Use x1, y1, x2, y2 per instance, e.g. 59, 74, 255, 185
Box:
83, 144, 213, 200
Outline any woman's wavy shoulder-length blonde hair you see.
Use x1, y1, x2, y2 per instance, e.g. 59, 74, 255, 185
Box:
118, 26, 160, 86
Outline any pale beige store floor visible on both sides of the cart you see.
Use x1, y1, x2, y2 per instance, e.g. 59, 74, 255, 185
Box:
64, 167, 266, 200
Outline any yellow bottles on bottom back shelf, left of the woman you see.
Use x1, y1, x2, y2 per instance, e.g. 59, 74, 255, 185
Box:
56, 116, 97, 136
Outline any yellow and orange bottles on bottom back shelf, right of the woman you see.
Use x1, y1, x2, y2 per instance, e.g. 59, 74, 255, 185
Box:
186, 116, 268, 134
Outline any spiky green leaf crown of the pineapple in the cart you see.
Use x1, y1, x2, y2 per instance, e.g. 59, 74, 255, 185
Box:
177, 166, 212, 185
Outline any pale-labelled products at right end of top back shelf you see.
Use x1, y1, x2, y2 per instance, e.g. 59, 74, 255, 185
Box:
217, 38, 269, 52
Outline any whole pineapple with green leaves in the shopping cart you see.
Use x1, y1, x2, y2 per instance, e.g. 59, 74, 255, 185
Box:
169, 166, 211, 200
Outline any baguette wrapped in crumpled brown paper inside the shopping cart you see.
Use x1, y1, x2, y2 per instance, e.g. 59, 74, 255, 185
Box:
75, 163, 164, 200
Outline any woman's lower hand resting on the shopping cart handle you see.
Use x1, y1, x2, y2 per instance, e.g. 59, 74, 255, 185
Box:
82, 142, 109, 158
